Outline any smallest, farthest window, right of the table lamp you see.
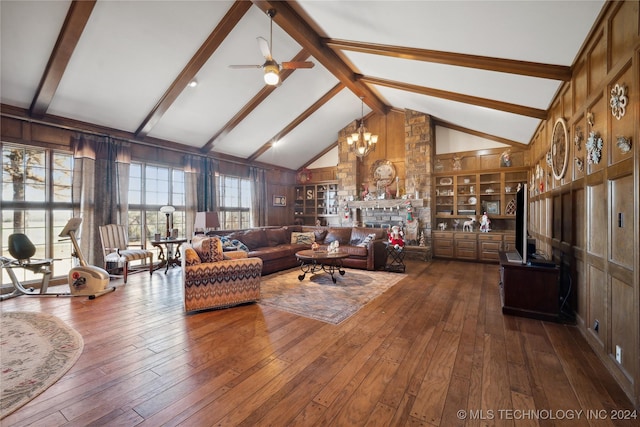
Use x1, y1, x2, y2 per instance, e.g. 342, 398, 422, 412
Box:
217, 175, 252, 230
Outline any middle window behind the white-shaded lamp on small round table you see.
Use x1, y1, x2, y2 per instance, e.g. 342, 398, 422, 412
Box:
128, 163, 186, 246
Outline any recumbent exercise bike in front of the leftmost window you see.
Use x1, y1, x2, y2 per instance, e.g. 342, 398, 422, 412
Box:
0, 218, 116, 301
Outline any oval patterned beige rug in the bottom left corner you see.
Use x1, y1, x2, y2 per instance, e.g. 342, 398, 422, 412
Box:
0, 311, 84, 419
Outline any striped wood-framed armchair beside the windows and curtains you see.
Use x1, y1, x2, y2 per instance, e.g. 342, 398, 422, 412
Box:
98, 224, 153, 283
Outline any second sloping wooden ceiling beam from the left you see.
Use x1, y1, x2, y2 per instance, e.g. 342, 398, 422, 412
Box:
135, 0, 251, 138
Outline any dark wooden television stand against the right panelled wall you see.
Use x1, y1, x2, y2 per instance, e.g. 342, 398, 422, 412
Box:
499, 252, 561, 322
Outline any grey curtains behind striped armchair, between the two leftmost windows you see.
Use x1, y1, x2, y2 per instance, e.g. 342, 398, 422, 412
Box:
72, 134, 131, 266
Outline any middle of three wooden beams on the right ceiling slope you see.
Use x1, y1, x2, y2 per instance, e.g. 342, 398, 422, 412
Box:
359, 76, 548, 120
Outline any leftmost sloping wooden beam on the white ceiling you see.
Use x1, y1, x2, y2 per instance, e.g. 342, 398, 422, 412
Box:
29, 0, 96, 117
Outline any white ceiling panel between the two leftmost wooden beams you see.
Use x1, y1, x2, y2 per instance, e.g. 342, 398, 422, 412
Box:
49, 1, 231, 131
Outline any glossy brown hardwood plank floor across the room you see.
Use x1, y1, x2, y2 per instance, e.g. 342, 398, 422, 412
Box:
0, 261, 640, 427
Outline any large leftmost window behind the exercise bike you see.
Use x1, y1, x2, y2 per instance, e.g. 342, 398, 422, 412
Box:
0, 143, 73, 286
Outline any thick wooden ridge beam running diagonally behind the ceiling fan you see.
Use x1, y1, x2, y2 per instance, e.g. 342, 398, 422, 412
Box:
252, 0, 389, 115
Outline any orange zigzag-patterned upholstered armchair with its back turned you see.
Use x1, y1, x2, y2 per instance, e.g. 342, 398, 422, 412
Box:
181, 236, 262, 312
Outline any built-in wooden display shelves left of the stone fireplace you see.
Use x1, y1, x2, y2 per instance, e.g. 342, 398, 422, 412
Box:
294, 181, 338, 225
